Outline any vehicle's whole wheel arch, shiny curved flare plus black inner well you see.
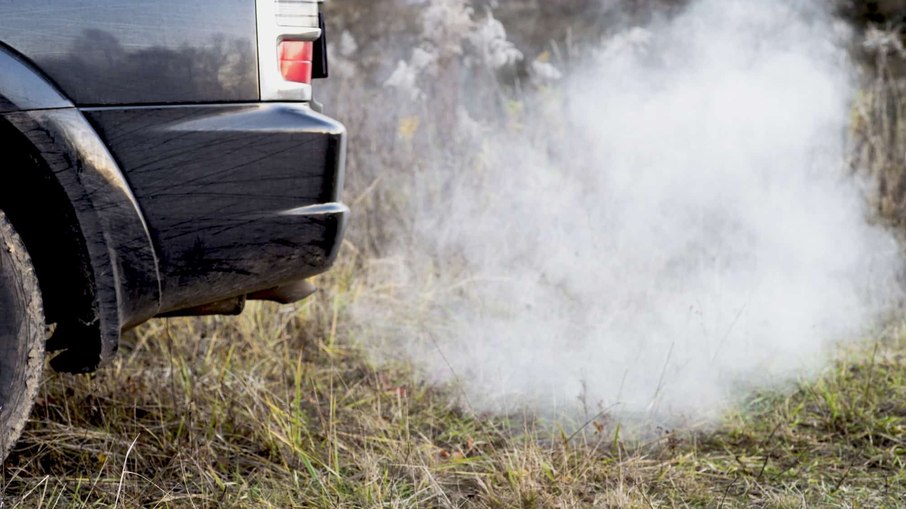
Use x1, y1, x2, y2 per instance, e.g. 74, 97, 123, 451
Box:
0, 46, 160, 372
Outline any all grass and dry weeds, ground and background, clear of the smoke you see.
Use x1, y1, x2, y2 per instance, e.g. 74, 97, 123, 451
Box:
0, 0, 906, 508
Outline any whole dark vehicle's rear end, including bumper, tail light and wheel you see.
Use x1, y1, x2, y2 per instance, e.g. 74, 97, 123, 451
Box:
0, 0, 348, 459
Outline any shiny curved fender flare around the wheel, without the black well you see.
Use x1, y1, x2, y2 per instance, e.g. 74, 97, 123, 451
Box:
0, 47, 160, 372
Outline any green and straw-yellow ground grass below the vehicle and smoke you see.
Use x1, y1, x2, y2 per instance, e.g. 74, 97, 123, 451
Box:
2, 252, 906, 508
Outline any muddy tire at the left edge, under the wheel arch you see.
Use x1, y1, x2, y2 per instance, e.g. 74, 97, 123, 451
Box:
0, 211, 45, 461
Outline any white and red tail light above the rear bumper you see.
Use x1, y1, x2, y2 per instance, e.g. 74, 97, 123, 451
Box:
257, 0, 326, 101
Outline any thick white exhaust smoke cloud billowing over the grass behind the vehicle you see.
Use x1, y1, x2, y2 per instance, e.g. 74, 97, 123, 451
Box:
342, 0, 899, 422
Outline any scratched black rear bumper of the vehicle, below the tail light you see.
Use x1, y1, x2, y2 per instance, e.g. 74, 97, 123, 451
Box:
83, 103, 348, 318
